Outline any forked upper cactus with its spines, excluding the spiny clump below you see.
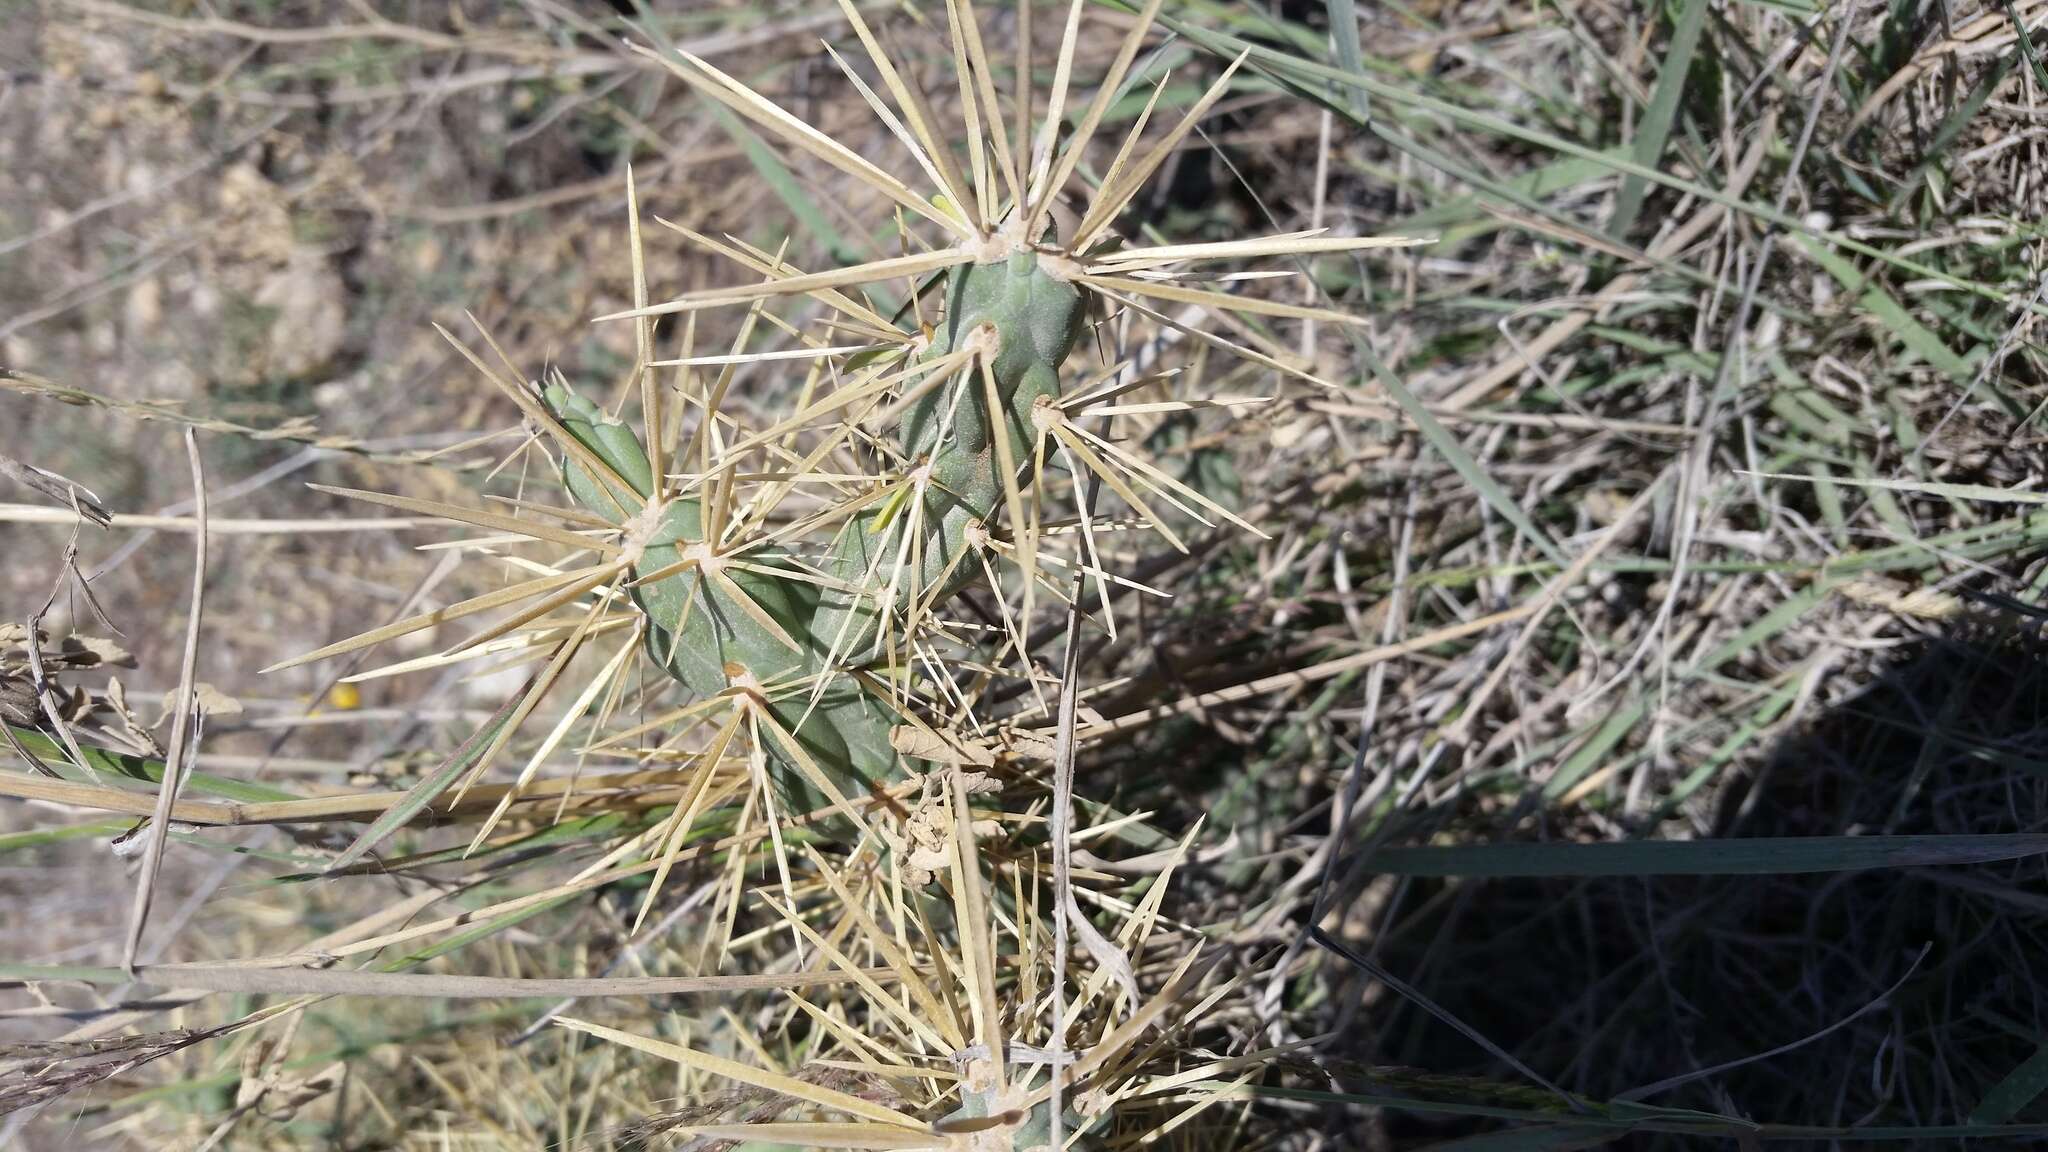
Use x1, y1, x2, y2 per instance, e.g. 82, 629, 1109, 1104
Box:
280, 0, 1417, 814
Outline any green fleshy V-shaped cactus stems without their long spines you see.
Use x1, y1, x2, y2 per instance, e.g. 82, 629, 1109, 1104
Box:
545, 250, 1083, 812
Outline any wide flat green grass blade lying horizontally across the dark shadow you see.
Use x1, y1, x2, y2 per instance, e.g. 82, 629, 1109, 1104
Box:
1372, 832, 2048, 877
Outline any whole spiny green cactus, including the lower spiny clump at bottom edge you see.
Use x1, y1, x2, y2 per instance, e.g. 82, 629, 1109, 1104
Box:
276, 0, 1411, 1152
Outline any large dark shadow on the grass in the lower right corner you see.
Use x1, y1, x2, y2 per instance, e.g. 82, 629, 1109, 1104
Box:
1346, 611, 2048, 1148
